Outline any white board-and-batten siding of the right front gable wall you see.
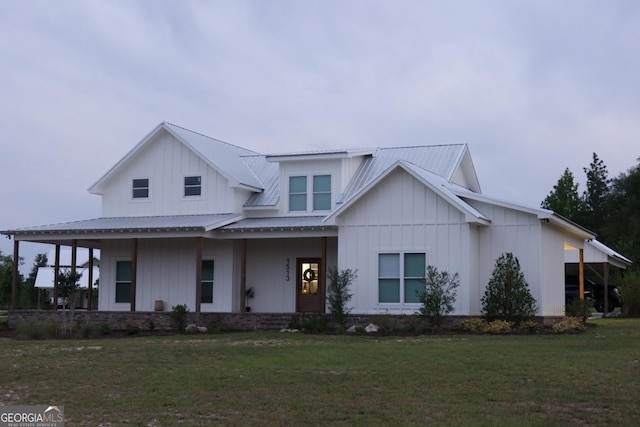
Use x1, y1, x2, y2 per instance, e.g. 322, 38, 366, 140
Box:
336, 170, 475, 315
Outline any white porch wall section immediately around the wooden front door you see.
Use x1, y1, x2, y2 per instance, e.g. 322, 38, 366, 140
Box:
242, 237, 337, 313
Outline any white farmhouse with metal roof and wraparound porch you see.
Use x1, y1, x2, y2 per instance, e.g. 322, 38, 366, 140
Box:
3, 123, 595, 317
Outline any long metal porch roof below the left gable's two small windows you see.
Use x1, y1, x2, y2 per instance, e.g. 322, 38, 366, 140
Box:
0, 213, 242, 247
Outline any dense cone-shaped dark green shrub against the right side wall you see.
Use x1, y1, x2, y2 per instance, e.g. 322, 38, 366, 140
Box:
482, 252, 536, 324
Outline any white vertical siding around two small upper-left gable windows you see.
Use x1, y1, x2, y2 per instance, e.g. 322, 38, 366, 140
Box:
102, 132, 250, 217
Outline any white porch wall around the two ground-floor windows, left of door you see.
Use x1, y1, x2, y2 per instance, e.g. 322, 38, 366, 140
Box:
98, 239, 233, 312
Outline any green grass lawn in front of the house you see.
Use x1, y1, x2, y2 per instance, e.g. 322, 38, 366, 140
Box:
0, 319, 640, 426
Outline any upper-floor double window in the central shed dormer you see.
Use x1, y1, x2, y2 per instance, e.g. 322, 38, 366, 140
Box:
289, 175, 331, 212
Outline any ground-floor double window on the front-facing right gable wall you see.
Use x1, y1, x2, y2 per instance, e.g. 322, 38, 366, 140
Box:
378, 252, 426, 303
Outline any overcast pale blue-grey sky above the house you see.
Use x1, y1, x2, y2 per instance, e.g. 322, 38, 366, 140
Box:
0, 0, 640, 266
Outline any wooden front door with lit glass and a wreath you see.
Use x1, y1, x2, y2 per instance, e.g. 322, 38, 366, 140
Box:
296, 258, 324, 313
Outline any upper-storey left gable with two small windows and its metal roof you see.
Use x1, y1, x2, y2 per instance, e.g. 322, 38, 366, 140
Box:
89, 123, 263, 217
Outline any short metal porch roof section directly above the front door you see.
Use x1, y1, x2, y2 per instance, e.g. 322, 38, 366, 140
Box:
215, 216, 338, 239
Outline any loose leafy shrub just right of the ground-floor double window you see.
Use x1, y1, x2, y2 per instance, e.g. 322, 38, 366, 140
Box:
418, 265, 460, 328
